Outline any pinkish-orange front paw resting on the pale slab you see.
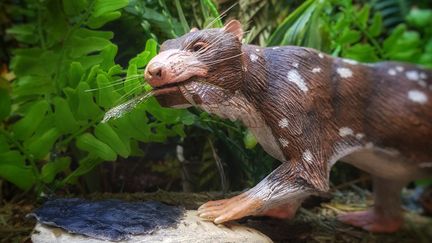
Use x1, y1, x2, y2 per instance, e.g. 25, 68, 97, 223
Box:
198, 193, 264, 224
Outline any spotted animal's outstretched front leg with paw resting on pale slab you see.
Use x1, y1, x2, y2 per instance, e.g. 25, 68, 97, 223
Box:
198, 161, 316, 224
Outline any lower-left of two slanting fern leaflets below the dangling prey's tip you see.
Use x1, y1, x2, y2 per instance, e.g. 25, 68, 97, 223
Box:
76, 133, 117, 161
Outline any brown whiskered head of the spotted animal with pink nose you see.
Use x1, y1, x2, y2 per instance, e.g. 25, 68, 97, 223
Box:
145, 20, 244, 107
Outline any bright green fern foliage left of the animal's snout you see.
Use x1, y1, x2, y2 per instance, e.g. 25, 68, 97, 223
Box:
0, 0, 194, 193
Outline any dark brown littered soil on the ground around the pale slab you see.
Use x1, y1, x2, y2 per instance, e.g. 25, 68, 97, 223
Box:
0, 191, 432, 242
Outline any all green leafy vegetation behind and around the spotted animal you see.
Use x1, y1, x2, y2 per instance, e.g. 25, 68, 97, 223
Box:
0, 0, 432, 196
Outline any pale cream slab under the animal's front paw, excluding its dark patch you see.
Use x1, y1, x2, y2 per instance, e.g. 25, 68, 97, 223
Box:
31, 210, 272, 243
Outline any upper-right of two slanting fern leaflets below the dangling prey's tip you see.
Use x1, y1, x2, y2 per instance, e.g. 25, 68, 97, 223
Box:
95, 123, 131, 158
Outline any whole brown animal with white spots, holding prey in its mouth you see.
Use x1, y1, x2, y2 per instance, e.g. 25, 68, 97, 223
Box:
145, 20, 432, 232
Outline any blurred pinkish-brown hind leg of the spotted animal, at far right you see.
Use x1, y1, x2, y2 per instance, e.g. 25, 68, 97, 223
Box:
338, 176, 406, 233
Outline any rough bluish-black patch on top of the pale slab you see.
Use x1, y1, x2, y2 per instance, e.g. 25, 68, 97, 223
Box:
28, 198, 184, 241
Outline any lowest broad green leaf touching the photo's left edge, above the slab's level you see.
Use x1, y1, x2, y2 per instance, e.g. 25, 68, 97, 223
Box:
0, 164, 36, 190
